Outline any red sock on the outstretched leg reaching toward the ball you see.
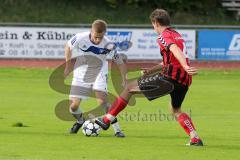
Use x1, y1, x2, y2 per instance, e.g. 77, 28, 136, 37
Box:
103, 97, 128, 123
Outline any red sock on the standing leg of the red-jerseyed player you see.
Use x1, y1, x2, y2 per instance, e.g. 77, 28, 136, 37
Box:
178, 113, 195, 135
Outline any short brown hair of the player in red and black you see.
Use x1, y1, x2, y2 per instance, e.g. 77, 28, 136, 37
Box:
150, 9, 170, 26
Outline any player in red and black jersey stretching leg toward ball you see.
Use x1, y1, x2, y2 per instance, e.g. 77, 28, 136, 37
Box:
95, 9, 203, 146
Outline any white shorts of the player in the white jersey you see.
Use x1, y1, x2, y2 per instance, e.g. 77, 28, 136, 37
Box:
69, 72, 108, 99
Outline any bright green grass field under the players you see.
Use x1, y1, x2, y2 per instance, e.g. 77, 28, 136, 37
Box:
0, 68, 240, 160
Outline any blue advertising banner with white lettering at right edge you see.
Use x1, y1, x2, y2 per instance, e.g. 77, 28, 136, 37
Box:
198, 30, 240, 60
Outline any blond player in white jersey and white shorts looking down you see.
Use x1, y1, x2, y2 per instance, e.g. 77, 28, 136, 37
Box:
64, 20, 127, 137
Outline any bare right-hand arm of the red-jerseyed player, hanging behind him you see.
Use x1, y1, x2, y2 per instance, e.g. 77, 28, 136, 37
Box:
170, 44, 197, 75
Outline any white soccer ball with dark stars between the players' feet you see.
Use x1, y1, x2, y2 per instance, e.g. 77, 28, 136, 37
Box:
82, 120, 100, 137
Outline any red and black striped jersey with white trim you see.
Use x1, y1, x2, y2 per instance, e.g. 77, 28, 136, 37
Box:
157, 28, 192, 86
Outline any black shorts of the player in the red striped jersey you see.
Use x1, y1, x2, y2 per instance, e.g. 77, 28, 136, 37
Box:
138, 73, 188, 109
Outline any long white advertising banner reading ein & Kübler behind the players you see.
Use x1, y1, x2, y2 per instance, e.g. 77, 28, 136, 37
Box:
0, 27, 196, 60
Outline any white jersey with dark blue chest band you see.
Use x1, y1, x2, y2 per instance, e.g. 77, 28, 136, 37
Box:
68, 32, 121, 83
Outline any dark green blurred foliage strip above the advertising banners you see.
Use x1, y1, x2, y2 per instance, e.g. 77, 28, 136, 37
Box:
0, 0, 236, 24
